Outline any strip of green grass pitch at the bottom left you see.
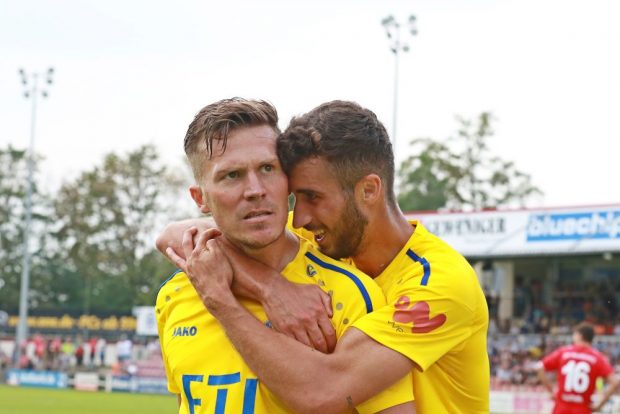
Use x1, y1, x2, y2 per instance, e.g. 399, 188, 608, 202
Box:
0, 385, 178, 414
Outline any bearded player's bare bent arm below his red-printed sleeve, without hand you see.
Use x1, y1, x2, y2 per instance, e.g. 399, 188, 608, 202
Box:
205, 284, 414, 413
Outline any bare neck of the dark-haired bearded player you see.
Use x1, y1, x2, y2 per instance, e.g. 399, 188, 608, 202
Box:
353, 204, 413, 277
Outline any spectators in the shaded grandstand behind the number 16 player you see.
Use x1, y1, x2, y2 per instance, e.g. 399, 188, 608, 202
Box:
487, 276, 620, 388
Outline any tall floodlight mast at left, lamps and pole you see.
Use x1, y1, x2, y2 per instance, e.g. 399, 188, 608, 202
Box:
13, 68, 54, 363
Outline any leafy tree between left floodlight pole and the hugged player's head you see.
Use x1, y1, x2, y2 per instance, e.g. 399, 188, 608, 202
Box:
50, 145, 187, 312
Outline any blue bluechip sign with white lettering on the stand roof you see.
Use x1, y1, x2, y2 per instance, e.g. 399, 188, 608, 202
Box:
527, 210, 620, 241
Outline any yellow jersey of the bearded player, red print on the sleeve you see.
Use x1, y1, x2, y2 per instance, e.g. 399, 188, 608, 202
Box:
353, 221, 489, 414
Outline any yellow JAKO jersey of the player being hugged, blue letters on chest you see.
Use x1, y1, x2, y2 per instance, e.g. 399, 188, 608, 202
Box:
156, 238, 413, 414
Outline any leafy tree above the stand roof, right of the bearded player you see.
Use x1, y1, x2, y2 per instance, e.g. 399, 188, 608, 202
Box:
398, 112, 542, 211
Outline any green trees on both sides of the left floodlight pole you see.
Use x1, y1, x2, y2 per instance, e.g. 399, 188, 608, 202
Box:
0, 145, 188, 313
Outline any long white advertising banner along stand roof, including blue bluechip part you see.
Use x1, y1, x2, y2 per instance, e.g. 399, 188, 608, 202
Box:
407, 204, 620, 258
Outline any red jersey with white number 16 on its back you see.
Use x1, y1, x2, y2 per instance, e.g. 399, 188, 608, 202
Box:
543, 345, 613, 414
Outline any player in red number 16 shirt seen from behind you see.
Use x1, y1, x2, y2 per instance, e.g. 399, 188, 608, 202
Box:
537, 323, 620, 414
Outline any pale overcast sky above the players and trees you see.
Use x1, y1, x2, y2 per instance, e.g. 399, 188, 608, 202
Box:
0, 0, 620, 207
